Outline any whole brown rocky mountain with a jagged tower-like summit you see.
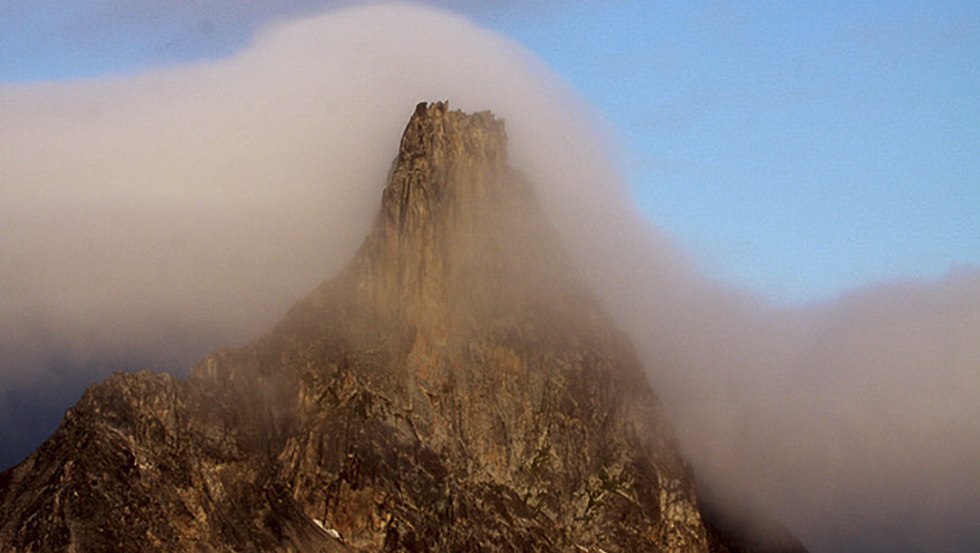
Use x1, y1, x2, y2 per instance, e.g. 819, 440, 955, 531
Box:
0, 103, 805, 553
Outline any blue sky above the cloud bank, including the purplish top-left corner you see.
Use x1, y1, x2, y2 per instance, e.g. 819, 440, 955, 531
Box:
0, 0, 980, 302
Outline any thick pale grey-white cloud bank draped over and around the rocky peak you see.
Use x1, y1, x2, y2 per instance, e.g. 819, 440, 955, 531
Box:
0, 5, 980, 551
